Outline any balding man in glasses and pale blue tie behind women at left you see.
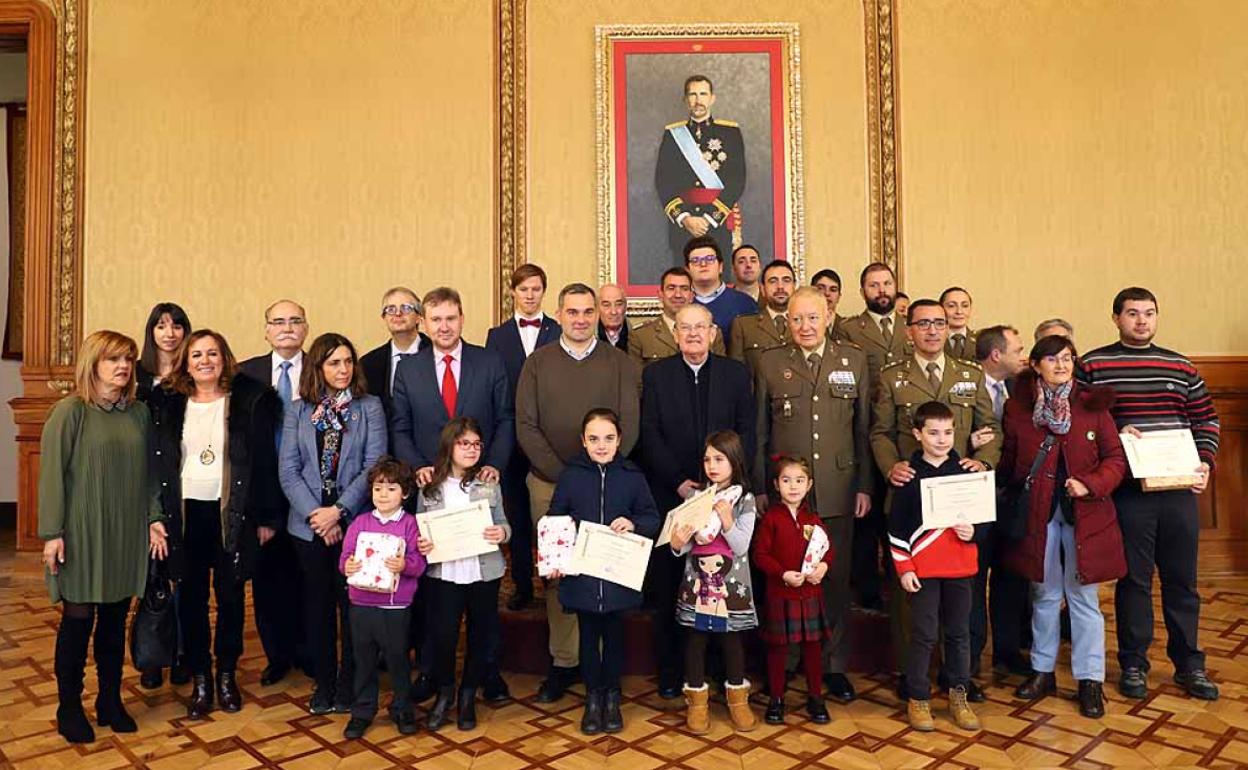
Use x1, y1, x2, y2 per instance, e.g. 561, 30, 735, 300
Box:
238, 300, 312, 686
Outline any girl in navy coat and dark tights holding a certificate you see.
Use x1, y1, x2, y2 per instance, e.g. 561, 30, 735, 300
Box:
548, 409, 660, 735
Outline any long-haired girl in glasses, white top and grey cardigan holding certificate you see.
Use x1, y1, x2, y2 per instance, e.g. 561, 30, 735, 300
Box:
416, 417, 512, 730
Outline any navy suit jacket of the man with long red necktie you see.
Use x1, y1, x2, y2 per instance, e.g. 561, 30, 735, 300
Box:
392, 342, 515, 472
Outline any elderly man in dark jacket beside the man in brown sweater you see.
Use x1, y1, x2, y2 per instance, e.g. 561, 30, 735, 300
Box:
639, 303, 755, 698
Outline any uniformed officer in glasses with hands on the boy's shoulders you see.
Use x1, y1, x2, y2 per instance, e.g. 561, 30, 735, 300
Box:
871, 300, 1002, 703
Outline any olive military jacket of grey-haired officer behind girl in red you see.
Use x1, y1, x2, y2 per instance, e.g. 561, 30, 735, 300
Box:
754, 341, 871, 518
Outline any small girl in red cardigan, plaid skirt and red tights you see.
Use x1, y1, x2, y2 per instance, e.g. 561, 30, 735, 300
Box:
754, 454, 832, 725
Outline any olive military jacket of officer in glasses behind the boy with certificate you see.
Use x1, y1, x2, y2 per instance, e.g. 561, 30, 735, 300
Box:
871, 356, 1002, 475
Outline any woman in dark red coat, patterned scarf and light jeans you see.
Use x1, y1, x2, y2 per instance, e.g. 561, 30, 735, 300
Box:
997, 336, 1127, 719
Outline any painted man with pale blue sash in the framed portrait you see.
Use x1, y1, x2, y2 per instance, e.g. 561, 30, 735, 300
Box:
654, 75, 745, 265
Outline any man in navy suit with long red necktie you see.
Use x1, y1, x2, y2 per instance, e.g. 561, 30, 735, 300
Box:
391, 286, 515, 703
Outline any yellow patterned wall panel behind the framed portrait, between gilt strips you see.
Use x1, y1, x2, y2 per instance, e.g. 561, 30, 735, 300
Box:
528, 0, 870, 315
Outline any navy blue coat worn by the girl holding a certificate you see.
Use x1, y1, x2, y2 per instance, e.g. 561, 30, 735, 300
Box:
549, 452, 663, 614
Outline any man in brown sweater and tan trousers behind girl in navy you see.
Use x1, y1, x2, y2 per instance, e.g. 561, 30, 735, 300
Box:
515, 283, 641, 703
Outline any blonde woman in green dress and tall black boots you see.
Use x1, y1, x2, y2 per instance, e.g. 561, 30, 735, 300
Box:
39, 331, 158, 744
